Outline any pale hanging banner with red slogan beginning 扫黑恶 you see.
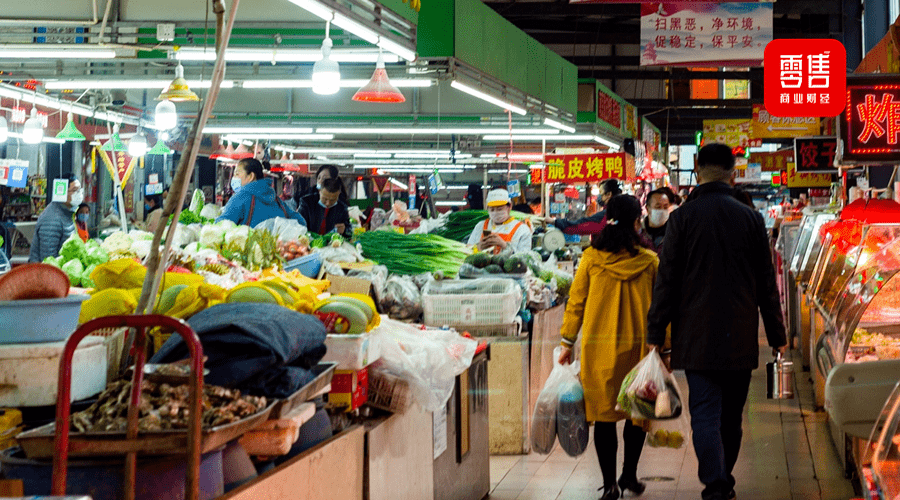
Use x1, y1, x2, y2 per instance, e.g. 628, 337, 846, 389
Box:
641, 2, 773, 66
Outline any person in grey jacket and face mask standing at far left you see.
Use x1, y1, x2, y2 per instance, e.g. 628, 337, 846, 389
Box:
28, 175, 84, 262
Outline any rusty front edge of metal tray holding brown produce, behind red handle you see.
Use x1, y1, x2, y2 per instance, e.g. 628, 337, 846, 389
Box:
16, 403, 278, 458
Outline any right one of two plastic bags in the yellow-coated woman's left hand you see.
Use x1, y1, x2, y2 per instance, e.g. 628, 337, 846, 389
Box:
555, 355, 588, 457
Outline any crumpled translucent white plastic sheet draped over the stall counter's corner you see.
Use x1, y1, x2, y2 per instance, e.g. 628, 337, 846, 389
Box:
373, 317, 478, 411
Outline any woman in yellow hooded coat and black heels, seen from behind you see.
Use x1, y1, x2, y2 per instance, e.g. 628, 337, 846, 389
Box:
559, 195, 659, 500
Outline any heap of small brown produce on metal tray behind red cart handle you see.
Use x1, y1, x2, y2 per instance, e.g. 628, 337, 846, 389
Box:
71, 380, 267, 432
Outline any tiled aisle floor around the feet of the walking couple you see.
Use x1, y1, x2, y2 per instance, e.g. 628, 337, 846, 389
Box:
489, 347, 855, 500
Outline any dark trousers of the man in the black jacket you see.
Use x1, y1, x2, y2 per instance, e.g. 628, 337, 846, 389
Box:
685, 370, 751, 498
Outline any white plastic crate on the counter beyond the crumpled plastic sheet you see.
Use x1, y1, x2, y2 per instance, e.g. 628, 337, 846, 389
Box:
422, 278, 523, 327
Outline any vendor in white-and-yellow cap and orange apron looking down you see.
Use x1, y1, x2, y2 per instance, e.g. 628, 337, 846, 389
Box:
468, 189, 531, 253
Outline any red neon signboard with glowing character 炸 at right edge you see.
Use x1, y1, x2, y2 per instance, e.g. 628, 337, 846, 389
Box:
841, 75, 900, 163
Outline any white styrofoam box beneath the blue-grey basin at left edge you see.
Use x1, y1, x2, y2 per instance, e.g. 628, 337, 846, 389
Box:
0, 336, 107, 407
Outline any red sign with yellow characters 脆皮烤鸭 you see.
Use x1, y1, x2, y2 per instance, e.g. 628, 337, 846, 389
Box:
546, 153, 634, 184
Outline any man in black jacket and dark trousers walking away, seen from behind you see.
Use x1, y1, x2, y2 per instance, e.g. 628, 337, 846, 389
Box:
647, 144, 787, 500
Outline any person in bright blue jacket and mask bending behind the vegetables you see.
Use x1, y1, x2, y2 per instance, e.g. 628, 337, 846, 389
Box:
216, 158, 306, 227
